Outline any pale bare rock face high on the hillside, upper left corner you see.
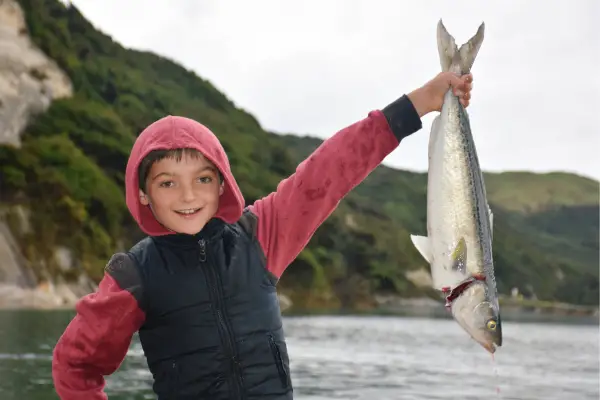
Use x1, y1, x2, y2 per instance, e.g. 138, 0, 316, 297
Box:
0, 0, 73, 146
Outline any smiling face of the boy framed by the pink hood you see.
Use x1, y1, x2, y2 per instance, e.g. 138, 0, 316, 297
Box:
140, 154, 223, 235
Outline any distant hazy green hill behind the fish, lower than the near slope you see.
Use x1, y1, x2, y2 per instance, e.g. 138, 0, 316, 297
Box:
282, 135, 600, 304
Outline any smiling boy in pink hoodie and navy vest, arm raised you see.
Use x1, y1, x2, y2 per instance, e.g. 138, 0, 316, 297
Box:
52, 73, 472, 400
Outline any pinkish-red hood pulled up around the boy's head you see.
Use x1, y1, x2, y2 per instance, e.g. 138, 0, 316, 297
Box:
125, 115, 244, 236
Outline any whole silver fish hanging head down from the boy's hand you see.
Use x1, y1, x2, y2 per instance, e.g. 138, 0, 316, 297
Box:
410, 19, 502, 354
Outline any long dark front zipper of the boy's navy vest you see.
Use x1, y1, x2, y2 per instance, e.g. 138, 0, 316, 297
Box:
198, 239, 243, 400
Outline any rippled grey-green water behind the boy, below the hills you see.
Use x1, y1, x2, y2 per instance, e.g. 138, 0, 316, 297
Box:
0, 311, 600, 400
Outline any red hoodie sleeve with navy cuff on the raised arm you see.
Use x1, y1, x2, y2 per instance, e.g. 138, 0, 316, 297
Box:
248, 95, 422, 278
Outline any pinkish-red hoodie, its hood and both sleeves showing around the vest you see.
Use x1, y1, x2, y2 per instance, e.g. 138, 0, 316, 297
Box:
52, 99, 420, 400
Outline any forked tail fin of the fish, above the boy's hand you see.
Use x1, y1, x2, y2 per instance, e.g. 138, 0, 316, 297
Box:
437, 19, 485, 75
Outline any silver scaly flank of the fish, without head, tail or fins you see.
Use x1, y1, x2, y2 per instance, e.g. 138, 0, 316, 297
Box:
428, 91, 495, 294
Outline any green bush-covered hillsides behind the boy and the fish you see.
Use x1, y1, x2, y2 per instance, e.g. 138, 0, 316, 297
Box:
0, 0, 599, 307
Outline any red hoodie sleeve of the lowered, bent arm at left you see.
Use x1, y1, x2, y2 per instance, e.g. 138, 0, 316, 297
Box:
52, 253, 144, 400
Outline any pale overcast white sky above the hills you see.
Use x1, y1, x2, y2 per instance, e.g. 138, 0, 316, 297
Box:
61, 0, 600, 179
